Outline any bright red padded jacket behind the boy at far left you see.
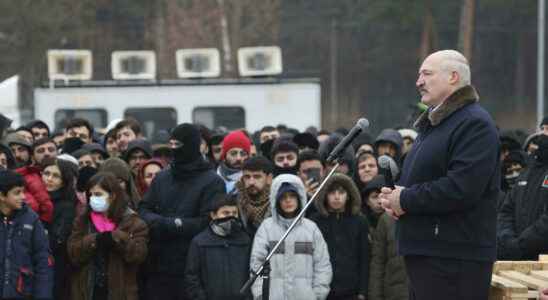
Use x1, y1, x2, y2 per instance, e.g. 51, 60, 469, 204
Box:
15, 166, 53, 223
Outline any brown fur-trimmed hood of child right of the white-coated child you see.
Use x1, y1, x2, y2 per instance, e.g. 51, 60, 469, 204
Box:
314, 173, 361, 216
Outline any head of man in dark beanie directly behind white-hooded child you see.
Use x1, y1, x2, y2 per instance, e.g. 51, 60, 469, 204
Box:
272, 138, 299, 177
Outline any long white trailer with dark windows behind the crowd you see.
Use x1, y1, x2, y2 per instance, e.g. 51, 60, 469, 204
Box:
34, 79, 321, 137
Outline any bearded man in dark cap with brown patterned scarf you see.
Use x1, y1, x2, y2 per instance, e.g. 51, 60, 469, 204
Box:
236, 156, 273, 237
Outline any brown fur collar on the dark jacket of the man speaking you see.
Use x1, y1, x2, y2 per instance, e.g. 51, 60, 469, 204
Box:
414, 85, 479, 129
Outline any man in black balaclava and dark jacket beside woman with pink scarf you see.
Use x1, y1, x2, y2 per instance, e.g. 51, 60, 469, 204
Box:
139, 124, 225, 300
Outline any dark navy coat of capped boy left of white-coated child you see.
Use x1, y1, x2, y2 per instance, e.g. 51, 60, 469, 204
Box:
185, 227, 251, 300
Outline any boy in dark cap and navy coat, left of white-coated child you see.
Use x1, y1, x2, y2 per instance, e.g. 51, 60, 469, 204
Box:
185, 197, 251, 300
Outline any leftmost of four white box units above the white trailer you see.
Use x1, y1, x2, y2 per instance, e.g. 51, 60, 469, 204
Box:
48, 50, 93, 81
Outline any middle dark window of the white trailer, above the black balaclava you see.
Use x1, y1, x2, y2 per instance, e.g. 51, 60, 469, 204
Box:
124, 107, 177, 140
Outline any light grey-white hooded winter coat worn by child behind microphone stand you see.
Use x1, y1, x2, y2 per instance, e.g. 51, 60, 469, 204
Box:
250, 174, 333, 300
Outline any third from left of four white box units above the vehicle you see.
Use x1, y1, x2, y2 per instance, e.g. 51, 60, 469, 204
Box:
175, 48, 221, 78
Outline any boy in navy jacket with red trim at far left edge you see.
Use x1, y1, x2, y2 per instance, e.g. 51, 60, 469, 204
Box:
0, 170, 53, 300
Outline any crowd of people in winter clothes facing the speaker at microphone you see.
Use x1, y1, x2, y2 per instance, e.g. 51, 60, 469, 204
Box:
0, 95, 548, 300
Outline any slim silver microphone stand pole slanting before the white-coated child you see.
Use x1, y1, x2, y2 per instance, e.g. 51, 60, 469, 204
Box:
240, 158, 340, 300
